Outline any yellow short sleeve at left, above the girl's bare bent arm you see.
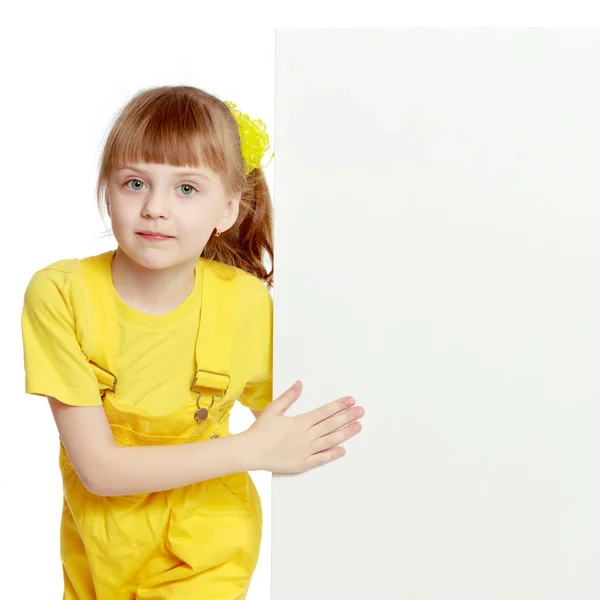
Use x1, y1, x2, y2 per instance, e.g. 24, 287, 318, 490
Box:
21, 268, 102, 406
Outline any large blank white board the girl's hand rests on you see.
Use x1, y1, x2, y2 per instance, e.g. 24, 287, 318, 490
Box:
272, 28, 600, 600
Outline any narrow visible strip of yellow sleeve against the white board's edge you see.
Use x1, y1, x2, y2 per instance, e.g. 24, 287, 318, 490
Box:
238, 281, 273, 411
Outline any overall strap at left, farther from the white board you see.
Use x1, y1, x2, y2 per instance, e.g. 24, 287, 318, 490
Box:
80, 250, 117, 400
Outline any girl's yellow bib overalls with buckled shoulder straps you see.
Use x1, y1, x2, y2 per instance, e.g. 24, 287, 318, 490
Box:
59, 253, 262, 600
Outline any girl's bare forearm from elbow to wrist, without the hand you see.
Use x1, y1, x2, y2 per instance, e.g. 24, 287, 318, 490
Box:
86, 432, 258, 496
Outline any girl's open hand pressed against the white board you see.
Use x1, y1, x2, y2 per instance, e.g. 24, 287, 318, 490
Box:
244, 381, 365, 473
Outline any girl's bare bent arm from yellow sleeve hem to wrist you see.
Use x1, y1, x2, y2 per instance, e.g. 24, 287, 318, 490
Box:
48, 396, 260, 496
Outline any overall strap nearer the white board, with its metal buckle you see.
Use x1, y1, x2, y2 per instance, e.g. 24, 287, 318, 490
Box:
190, 259, 238, 423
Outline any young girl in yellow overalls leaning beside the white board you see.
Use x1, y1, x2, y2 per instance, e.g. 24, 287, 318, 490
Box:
22, 86, 364, 600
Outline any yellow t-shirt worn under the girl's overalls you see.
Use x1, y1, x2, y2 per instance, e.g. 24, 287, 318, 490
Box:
21, 251, 273, 416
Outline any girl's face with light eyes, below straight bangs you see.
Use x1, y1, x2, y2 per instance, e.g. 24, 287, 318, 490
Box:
107, 163, 240, 268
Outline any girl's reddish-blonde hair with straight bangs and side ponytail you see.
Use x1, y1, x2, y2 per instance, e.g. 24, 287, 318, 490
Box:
96, 85, 274, 288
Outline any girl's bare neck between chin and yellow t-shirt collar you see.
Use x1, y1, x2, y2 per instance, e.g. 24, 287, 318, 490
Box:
112, 248, 196, 315
